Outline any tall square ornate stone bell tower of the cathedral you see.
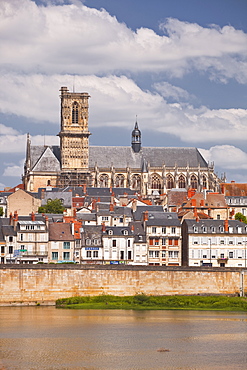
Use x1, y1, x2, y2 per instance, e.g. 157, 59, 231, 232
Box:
58, 87, 91, 186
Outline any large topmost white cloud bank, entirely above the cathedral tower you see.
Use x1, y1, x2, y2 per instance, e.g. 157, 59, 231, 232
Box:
0, 0, 247, 83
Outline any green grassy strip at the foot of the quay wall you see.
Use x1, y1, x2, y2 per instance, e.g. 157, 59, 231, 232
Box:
56, 294, 247, 311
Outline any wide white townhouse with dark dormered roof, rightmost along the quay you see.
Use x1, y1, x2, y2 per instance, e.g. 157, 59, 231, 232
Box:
182, 219, 247, 267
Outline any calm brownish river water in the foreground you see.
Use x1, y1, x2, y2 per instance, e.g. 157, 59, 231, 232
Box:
0, 307, 247, 370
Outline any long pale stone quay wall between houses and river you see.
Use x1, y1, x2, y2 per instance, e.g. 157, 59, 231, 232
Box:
0, 265, 247, 305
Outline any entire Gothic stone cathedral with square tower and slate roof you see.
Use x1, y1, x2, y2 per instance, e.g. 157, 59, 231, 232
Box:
23, 87, 220, 196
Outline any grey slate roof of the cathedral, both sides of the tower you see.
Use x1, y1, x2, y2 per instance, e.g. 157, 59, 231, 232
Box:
31, 146, 208, 172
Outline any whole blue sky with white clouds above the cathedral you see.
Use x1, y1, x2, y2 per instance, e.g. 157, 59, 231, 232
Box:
0, 0, 247, 189
